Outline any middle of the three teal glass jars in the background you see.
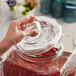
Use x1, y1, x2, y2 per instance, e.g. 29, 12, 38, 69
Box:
52, 0, 64, 18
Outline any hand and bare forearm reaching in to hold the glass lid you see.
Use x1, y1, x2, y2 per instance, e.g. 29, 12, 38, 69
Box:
0, 16, 37, 56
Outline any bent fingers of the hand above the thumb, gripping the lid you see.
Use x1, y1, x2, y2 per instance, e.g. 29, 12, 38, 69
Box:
10, 16, 35, 31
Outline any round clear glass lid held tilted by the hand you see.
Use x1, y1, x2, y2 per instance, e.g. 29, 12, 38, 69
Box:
15, 16, 62, 55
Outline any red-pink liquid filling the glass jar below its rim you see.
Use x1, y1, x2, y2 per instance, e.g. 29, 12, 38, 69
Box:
3, 51, 70, 76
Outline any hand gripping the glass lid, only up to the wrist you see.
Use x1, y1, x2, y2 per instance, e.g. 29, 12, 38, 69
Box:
5, 16, 37, 45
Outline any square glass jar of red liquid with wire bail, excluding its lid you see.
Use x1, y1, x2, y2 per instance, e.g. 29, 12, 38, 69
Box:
3, 35, 75, 76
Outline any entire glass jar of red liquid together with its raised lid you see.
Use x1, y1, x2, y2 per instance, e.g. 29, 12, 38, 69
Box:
2, 16, 75, 76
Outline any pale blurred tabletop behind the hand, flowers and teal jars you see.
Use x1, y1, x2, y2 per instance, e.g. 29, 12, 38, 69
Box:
0, 0, 76, 56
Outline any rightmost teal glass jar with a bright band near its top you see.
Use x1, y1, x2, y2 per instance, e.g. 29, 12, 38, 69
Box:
63, 0, 76, 23
